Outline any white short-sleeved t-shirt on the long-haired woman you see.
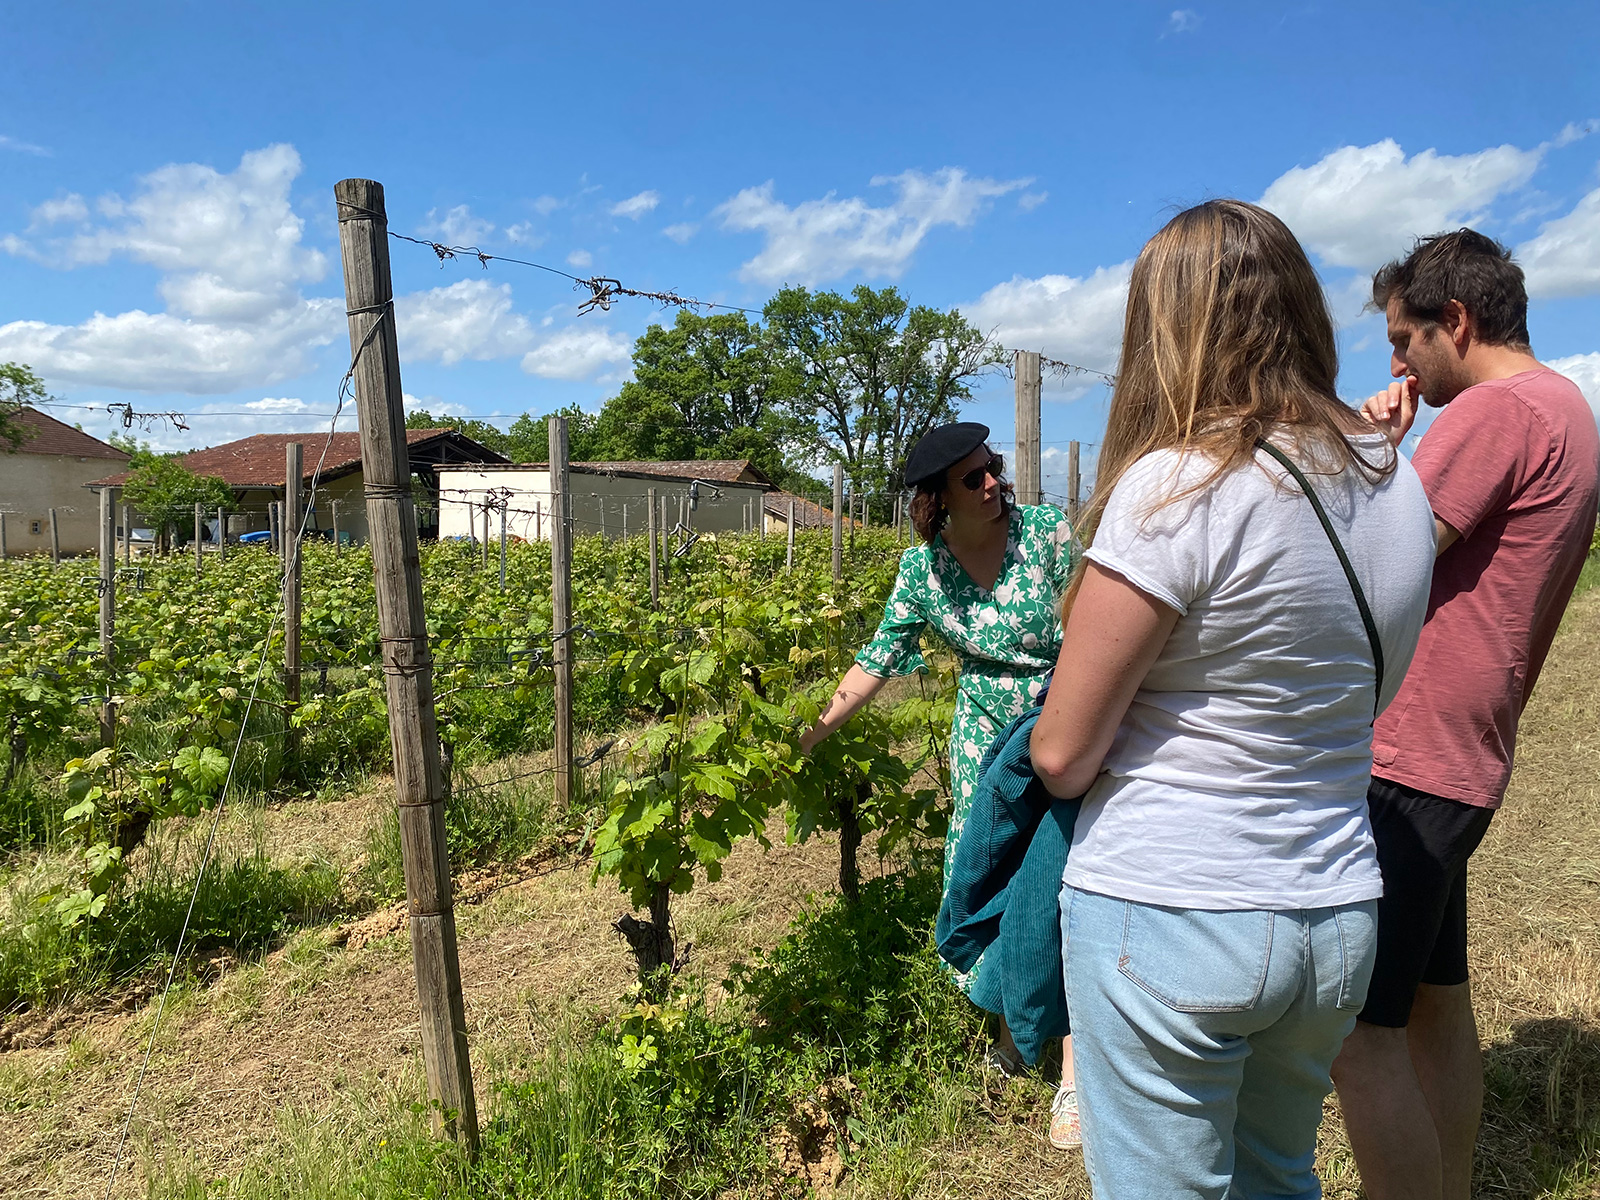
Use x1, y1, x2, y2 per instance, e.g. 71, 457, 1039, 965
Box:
1064, 434, 1434, 910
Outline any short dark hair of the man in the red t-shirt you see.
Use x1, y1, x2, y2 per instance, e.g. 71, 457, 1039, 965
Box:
1373, 229, 1528, 347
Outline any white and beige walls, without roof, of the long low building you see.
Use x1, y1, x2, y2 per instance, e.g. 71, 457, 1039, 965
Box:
438, 467, 765, 541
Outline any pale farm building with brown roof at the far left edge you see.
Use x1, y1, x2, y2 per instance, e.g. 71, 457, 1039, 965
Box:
0, 408, 128, 554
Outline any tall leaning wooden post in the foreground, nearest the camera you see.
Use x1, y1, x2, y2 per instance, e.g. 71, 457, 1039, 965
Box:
333, 179, 478, 1154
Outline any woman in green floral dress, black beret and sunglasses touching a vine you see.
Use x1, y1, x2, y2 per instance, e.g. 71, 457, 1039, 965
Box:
802, 422, 1077, 1149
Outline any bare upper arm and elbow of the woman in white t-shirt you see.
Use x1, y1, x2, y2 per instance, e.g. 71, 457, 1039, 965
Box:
1029, 562, 1178, 798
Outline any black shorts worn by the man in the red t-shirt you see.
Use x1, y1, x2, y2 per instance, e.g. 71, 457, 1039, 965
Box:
1360, 776, 1494, 1029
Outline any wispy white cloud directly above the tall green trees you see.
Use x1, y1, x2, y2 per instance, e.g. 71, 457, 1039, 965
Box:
715, 166, 1032, 285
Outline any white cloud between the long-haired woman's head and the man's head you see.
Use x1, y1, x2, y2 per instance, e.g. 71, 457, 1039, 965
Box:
1261, 138, 1544, 270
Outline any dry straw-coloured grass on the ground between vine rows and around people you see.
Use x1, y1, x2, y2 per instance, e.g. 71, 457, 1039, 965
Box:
0, 590, 1600, 1200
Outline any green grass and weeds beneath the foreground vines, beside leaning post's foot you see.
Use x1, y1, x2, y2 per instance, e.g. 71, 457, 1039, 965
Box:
152, 874, 981, 1200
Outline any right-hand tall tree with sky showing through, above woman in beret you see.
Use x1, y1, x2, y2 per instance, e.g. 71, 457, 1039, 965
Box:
763, 286, 1002, 490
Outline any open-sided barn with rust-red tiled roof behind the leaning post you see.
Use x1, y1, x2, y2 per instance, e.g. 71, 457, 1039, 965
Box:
88, 429, 506, 544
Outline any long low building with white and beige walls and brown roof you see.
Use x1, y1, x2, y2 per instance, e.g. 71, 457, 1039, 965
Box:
437, 459, 787, 541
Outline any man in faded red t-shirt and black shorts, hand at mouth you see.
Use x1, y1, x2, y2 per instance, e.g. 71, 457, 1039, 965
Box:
1333, 229, 1600, 1200
